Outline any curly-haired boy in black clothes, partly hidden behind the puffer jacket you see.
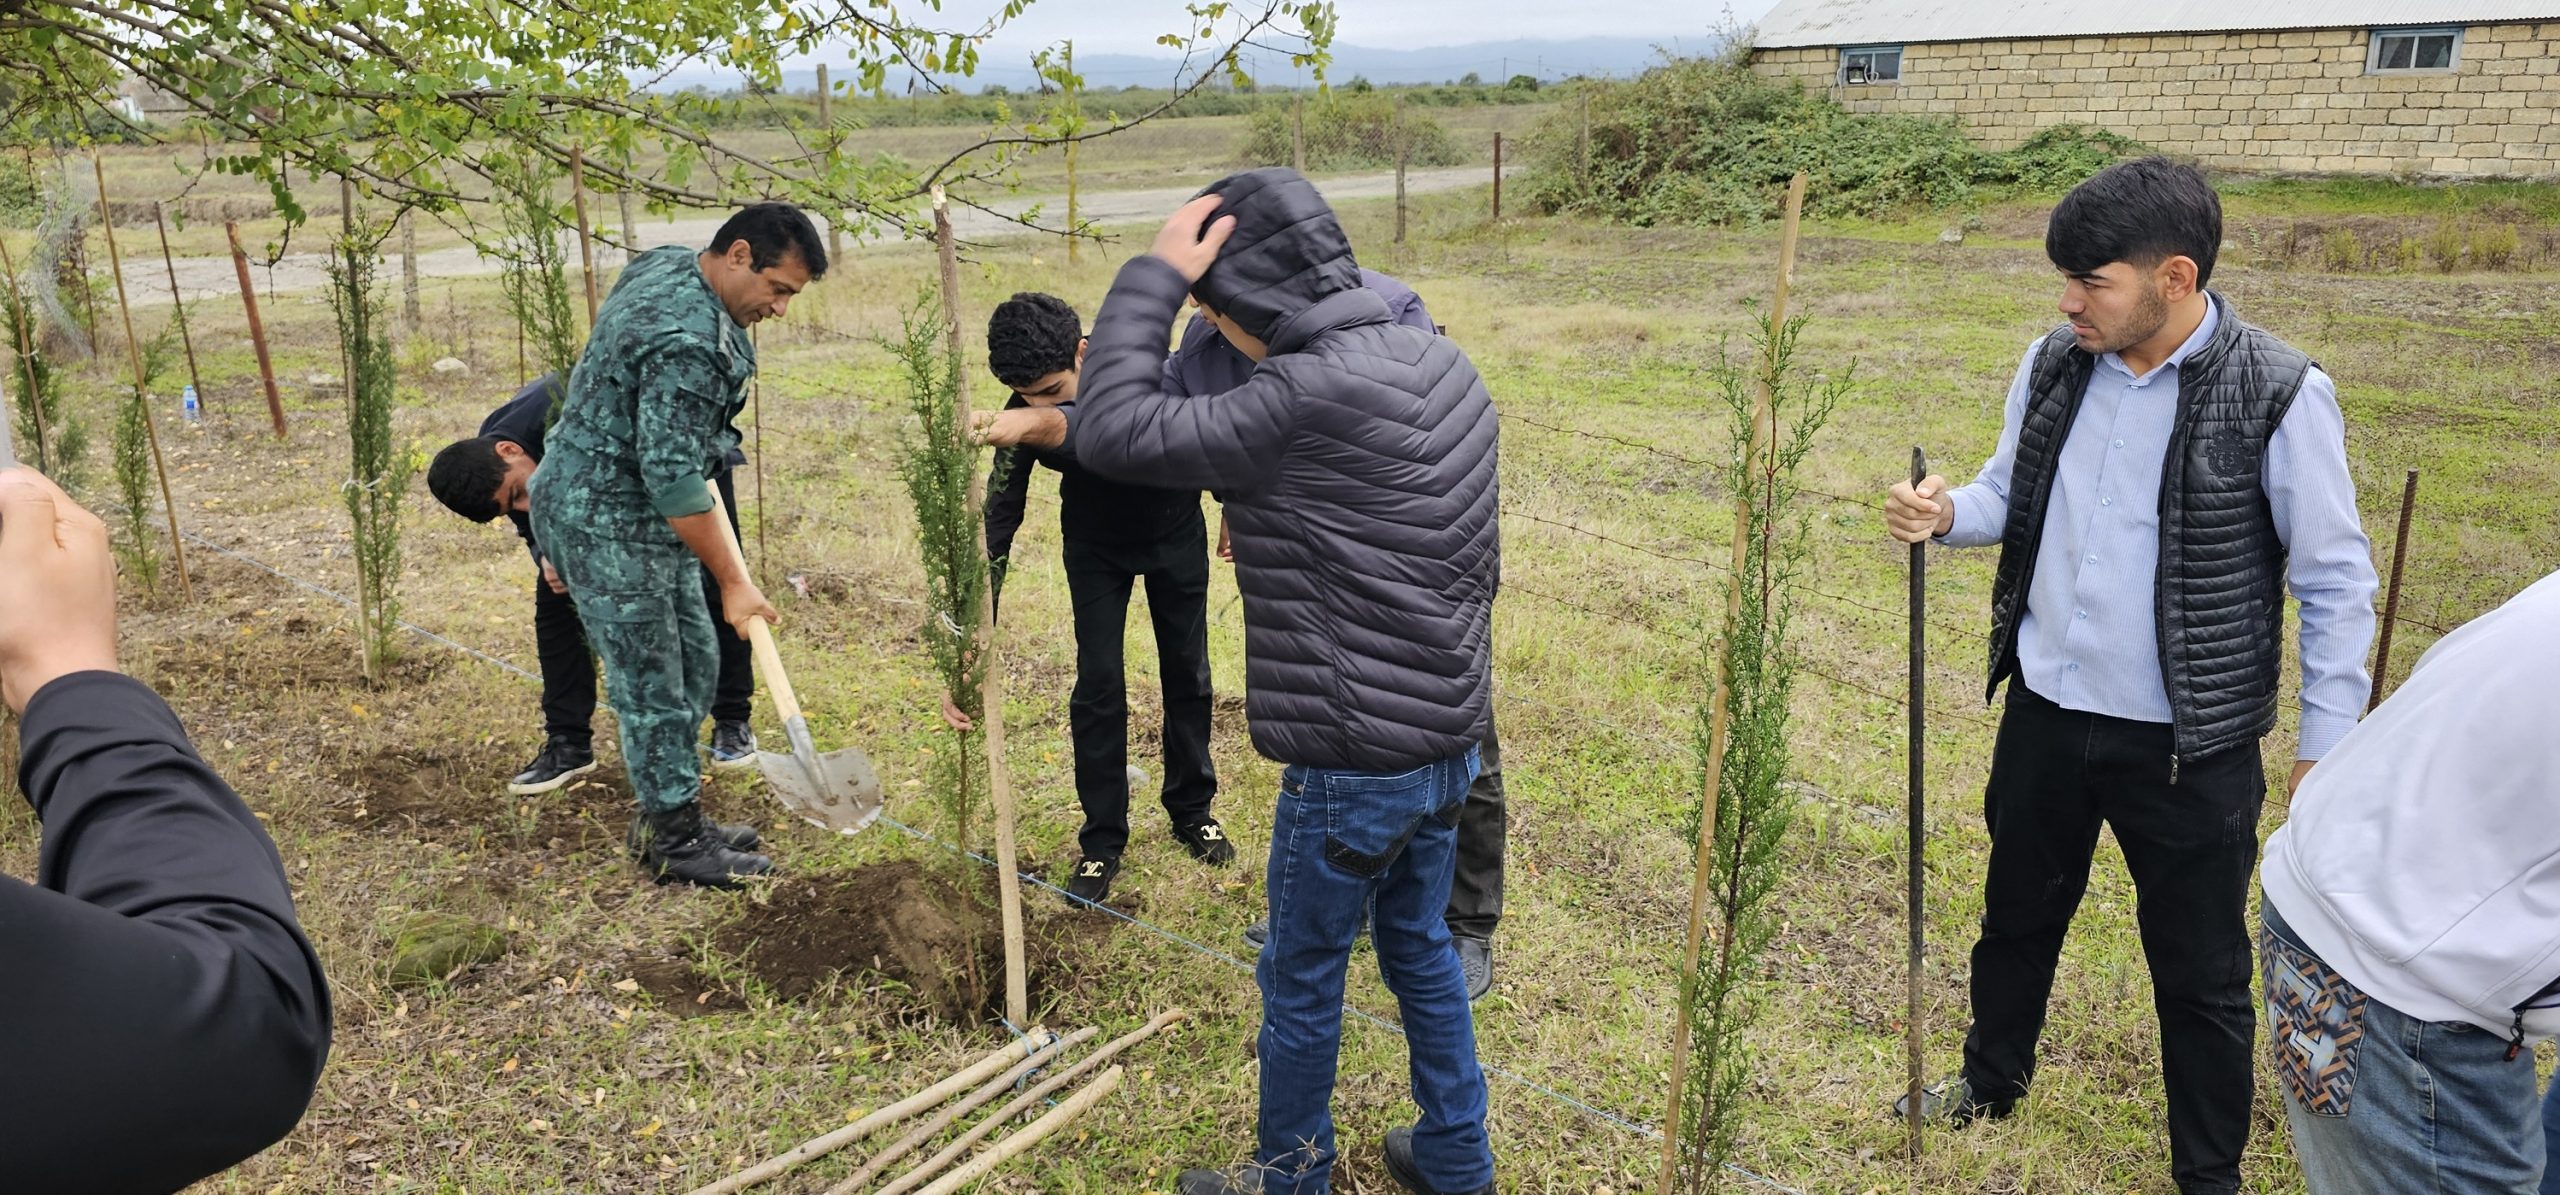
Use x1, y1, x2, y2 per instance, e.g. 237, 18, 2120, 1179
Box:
945, 294, 1236, 903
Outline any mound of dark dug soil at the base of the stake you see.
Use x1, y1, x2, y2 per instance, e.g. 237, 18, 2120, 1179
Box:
630, 860, 1116, 1024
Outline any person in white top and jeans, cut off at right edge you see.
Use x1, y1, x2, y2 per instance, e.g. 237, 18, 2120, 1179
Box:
2260, 573, 2560, 1195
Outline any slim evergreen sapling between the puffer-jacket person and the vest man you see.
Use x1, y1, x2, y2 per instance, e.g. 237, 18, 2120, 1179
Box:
1677, 305, 1848, 1192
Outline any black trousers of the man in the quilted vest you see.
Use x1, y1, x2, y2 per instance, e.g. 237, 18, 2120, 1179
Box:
1964, 681, 2266, 1195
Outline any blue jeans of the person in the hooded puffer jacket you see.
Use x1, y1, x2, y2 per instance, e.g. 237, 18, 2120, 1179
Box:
1254, 750, 1492, 1195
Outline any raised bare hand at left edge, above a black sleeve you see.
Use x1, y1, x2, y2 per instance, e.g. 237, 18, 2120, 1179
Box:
0, 468, 118, 714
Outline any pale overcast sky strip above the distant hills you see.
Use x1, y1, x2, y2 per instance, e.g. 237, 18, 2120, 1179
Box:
798, 0, 1774, 59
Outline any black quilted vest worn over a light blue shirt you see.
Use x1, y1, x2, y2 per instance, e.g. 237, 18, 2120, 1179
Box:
1987, 294, 2312, 780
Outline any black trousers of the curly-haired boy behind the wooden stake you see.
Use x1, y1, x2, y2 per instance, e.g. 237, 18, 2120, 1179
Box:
1060, 522, 1219, 860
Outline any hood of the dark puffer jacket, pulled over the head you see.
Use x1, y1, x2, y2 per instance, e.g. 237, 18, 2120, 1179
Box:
1190, 166, 1359, 340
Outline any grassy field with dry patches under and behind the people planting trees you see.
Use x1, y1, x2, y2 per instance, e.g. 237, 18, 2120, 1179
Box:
0, 156, 2560, 1195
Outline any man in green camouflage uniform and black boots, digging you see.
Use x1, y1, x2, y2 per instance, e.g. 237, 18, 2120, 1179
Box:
532, 202, 827, 888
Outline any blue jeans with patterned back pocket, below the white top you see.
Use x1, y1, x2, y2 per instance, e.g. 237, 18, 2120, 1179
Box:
2258, 903, 2542, 1195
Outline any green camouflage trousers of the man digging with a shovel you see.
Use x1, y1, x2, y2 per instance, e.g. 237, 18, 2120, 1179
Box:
535, 529, 719, 814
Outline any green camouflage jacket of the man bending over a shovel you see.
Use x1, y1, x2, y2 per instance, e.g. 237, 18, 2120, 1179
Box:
535, 246, 755, 548
